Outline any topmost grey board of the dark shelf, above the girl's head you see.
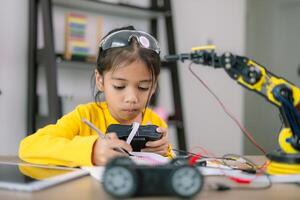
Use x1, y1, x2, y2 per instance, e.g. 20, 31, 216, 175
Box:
52, 0, 170, 19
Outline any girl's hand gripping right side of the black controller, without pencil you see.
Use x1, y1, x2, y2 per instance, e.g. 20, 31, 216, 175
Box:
141, 127, 169, 156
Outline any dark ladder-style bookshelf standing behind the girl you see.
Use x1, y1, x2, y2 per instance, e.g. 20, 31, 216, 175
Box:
27, 0, 187, 150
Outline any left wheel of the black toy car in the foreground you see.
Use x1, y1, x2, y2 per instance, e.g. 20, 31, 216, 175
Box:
103, 165, 137, 198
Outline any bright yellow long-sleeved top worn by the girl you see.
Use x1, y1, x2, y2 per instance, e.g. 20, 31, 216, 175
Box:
19, 102, 173, 167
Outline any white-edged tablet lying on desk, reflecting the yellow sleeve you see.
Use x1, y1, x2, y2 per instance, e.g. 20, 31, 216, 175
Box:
0, 162, 88, 192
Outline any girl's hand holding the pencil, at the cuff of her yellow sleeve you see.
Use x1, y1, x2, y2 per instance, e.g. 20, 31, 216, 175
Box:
92, 133, 132, 165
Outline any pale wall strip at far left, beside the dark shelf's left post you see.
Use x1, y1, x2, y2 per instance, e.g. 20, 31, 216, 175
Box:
0, 0, 28, 155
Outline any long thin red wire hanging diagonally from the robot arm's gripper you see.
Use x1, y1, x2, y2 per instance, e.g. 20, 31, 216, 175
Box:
189, 63, 266, 155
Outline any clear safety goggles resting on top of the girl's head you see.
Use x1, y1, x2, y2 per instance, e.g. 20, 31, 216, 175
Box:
100, 30, 160, 54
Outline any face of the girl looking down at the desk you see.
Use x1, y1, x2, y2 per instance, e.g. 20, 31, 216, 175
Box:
96, 60, 156, 124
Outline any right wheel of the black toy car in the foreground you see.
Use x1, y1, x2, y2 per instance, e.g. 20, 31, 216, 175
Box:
170, 165, 203, 198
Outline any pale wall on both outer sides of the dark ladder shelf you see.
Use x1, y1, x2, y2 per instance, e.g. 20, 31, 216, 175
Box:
0, 0, 245, 154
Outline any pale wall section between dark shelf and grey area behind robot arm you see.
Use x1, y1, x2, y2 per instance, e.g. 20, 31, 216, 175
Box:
172, 0, 246, 154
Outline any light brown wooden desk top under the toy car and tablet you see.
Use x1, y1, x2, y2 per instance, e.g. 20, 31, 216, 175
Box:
0, 156, 300, 200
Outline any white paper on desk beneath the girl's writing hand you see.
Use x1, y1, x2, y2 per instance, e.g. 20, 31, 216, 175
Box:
81, 152, 169, 181
